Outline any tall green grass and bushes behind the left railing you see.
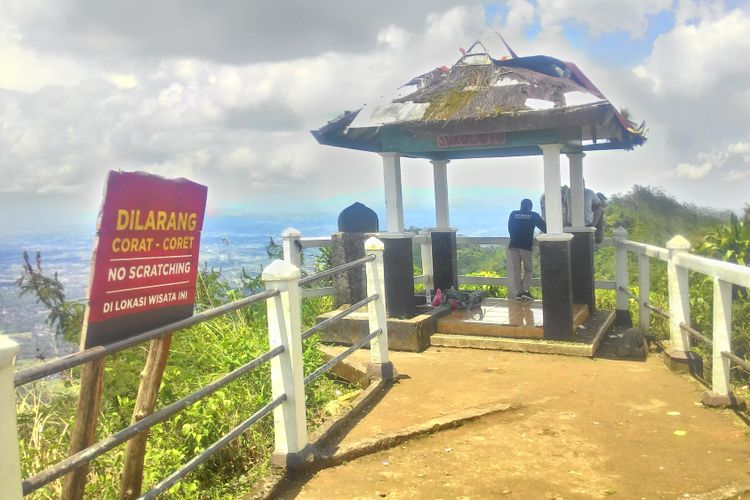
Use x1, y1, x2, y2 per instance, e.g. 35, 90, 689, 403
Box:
17, 272, 353, 499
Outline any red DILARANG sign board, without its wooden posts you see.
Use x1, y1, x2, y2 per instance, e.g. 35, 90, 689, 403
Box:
81, 172, 208, 349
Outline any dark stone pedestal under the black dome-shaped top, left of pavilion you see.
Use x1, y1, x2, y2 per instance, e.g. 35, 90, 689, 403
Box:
331, 233, 370, 309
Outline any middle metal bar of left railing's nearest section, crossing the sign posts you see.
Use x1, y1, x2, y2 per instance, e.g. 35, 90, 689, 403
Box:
23, 346, 284, 495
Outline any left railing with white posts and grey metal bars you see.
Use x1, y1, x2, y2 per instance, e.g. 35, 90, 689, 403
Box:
0, 238, 394, 500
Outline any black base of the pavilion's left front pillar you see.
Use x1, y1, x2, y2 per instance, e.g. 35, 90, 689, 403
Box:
377, 233, 415, 318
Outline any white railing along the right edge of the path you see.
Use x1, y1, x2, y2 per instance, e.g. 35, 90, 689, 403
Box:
614, 227, 750, 397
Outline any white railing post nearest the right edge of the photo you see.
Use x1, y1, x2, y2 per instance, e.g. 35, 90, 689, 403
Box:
703, 278, 737, 406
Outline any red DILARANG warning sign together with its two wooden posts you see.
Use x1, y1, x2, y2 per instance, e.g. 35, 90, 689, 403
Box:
62, 172, 207, 500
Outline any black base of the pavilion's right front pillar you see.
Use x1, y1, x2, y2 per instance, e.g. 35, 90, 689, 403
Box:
536, 234, 573, 340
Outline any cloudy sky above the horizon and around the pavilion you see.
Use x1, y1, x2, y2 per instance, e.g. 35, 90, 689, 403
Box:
0, 0, 750, 229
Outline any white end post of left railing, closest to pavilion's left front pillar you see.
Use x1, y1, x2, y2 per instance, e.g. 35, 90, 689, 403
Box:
365, 237, 396, 380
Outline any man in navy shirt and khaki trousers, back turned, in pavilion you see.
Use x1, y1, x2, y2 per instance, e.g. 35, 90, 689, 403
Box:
507, 199, 547, 300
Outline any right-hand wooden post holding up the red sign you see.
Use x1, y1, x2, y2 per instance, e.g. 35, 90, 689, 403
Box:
118, 333, 172, 500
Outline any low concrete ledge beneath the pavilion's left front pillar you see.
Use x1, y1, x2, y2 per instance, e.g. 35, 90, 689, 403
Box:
318, 306, 450, 352
